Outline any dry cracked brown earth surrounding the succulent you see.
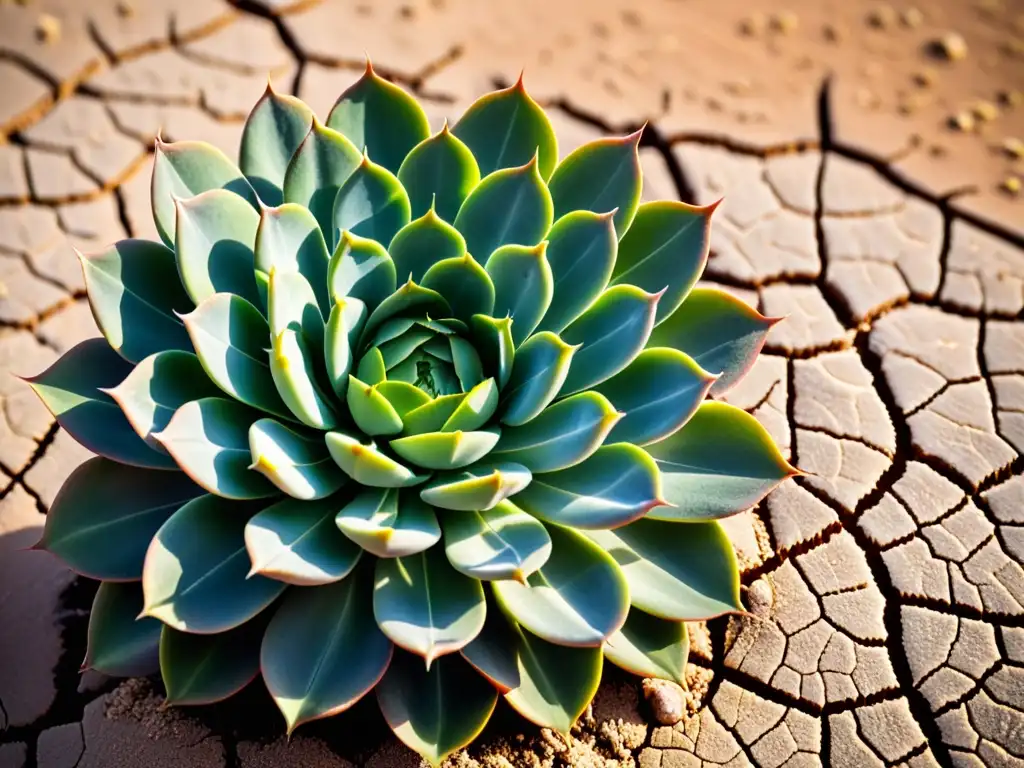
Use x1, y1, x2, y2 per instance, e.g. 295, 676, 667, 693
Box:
0, 0, 1024, 768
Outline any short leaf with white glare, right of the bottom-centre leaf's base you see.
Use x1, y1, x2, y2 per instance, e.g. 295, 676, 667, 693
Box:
441, 501, 551, 582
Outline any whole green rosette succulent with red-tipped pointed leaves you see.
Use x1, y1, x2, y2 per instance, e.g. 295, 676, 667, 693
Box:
29, 66, 796, 763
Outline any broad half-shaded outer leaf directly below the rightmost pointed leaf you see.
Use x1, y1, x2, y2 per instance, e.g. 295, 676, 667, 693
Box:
586, 519, 742, 622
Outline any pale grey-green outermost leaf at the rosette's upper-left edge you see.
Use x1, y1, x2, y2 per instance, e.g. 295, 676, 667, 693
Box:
152, 138, 259, 246
